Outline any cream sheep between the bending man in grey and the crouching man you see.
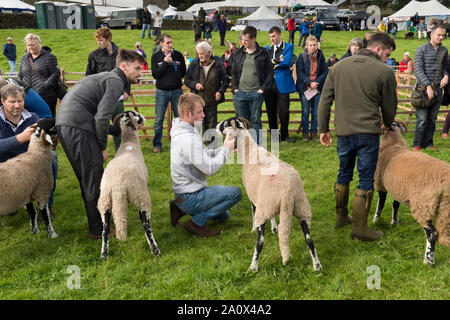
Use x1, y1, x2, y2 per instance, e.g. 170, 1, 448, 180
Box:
97, 111, 160, 260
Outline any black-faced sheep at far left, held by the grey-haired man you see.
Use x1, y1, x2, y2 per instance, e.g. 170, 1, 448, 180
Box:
0, 118, 58, 238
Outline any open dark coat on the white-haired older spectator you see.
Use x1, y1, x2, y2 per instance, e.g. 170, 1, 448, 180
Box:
184, 57, 230, 104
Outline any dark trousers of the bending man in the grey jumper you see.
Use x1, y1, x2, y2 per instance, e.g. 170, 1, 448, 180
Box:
57, 126, 103, 235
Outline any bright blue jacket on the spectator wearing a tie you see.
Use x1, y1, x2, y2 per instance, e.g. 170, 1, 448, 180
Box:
266, 41, 296, 94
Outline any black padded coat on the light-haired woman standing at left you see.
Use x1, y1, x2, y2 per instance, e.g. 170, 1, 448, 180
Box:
18, 48, 61, 97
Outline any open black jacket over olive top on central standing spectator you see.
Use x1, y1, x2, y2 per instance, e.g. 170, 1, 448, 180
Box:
231, 43, 274, 92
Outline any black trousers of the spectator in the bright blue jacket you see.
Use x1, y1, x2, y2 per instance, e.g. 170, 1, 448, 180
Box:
264, 81, 290, 140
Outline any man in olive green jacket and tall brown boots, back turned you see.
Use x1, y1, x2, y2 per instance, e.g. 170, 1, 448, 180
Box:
319, 32, 397, 241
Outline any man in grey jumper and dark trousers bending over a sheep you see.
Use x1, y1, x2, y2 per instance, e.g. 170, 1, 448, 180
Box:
56, 49, 144, 239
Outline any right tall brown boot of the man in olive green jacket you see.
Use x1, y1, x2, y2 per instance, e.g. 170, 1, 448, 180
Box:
351, 189, 383, 241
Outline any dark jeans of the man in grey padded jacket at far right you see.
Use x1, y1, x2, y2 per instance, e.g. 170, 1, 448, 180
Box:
412, 88, 442, 148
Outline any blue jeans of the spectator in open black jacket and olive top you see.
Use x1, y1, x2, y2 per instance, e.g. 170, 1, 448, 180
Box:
233, 91, 264, 145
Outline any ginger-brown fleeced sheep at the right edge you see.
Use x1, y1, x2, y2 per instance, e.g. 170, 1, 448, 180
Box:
374, 120, 450, 265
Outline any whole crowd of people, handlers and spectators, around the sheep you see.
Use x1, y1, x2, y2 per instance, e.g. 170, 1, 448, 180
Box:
0, 16, 450, 241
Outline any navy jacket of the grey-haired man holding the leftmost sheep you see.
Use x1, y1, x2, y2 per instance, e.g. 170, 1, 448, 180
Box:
0, 107, 39, 162
